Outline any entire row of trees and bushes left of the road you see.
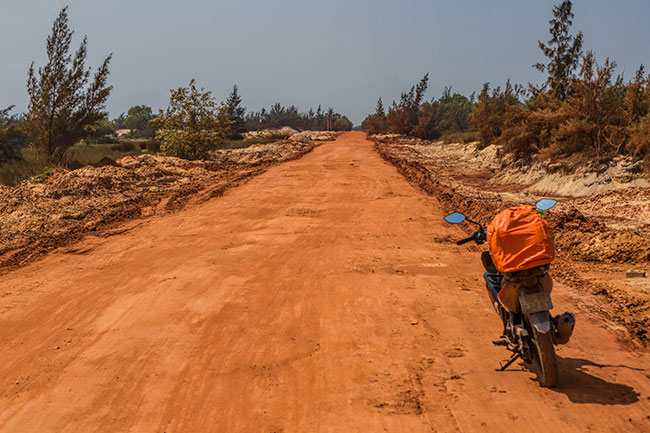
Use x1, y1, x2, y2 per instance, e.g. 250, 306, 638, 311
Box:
0, 6, 352, 165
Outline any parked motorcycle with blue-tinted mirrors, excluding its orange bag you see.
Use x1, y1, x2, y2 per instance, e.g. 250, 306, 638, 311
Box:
444, 199, 575, 388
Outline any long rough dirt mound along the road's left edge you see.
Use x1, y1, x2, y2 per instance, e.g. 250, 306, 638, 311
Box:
0, 142, 315, 269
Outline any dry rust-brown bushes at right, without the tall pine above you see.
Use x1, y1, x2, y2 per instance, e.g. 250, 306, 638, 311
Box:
496, 52, 648, 163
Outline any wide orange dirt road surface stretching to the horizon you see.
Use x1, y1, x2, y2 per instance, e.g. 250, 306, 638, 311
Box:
0, 133, 650, 432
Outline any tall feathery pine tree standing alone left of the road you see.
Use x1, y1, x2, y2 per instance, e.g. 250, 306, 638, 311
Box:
25, 6, 113, 163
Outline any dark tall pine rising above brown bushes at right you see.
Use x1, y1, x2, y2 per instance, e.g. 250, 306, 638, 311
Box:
533, 0, 582, 101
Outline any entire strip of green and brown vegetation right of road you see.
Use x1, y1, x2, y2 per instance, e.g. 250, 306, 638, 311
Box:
363, 0, 650, 173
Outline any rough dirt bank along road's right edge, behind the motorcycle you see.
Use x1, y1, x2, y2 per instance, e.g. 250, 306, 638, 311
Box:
376, 137, 650, 263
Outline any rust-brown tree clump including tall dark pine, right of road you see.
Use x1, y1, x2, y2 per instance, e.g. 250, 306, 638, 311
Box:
472, 0, 650, 163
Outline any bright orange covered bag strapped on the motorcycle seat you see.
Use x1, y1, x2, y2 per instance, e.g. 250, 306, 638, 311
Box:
487, 206, 555, 272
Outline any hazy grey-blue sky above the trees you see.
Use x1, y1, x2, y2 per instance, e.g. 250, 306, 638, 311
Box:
0, 0, 650, 124
